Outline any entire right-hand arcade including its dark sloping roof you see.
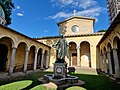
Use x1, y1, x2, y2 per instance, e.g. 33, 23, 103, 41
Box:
97, 13, 120, 80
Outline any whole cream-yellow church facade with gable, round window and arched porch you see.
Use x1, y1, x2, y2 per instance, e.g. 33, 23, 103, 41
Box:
35, 15, 104, 69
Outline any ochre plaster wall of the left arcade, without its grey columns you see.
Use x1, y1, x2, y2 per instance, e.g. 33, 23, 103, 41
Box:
0, 25, 50, 71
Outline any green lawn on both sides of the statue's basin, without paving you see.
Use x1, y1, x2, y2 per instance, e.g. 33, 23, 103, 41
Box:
0, 71, 120, 90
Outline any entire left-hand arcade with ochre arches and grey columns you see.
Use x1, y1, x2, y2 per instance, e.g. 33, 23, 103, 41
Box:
0, 26, 50, 74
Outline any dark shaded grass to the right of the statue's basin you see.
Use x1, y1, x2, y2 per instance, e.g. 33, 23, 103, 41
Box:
70, 74, 120, 90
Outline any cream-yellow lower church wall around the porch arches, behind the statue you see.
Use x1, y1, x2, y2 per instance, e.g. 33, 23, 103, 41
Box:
38, 35, 103, 68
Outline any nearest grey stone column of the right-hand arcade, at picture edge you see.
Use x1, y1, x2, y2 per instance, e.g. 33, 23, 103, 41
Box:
113, 48, 120, 78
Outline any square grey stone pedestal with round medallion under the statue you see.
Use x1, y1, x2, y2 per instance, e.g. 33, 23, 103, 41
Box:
54, 62, 67, 79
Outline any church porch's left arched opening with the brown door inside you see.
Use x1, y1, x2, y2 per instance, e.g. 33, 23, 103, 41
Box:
69, 42, 77, 66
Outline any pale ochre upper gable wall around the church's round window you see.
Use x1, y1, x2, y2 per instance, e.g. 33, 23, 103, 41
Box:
59, 18, 94, 35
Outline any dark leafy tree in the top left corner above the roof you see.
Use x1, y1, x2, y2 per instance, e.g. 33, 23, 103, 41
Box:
0, 0, 14, 26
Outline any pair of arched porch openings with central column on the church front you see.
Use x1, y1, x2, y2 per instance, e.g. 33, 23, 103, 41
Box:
69, 41, 91, 67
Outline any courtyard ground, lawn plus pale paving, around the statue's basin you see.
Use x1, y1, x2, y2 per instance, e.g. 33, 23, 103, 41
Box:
0, 67, 120, 90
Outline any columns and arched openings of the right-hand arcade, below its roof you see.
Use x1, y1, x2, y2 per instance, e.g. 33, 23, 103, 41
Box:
99, 36, 120, 78
